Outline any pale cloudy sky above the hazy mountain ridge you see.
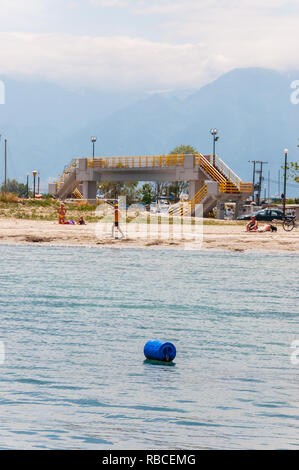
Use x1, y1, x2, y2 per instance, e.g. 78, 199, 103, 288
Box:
0, 0, 299, 91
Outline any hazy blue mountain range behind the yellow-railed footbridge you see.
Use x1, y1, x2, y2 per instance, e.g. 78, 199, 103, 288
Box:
0, 68, 299, 194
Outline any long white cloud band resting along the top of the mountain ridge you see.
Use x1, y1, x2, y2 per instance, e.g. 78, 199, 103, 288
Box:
0, 31, 297, 89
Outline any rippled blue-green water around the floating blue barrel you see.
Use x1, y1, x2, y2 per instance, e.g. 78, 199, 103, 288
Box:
0, 245, 299, 449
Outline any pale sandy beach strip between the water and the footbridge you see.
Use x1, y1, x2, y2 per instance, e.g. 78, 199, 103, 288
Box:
0, 218, 299, 252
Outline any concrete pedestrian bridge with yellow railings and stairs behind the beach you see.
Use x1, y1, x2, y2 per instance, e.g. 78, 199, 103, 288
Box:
49, 153, 252, 215
